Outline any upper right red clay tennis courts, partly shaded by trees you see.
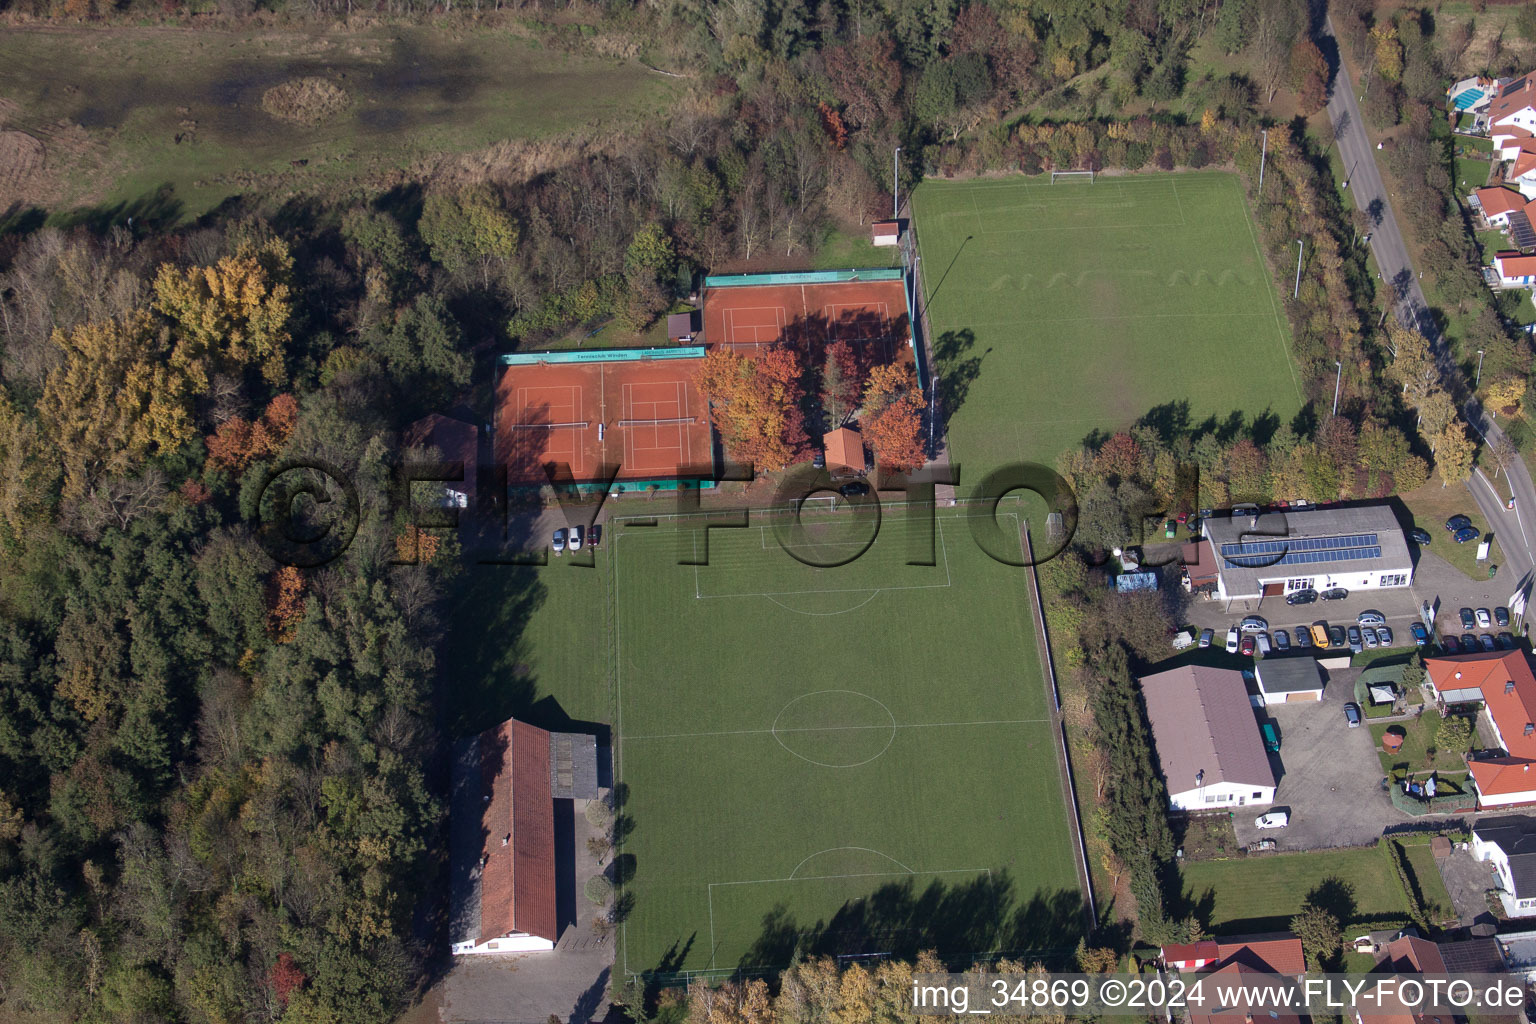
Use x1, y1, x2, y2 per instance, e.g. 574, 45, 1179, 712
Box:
703, 272, 911, 362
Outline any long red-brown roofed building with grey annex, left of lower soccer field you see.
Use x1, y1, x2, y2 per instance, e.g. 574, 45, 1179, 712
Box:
452, 720, 598, 953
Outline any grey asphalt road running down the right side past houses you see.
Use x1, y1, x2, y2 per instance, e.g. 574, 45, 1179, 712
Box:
1322, 20, 1536, 617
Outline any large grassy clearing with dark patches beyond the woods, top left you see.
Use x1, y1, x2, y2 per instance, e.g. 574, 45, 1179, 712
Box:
0, 26, 679, 216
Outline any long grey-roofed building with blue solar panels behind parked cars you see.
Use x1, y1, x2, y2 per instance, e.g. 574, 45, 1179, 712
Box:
1201, 505, 1413, 602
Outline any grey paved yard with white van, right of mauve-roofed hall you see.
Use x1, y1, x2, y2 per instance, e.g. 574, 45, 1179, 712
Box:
1235, 669, 1409, 851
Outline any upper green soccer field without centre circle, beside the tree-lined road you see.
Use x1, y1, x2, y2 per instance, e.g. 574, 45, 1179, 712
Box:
912, 172, 1303, 473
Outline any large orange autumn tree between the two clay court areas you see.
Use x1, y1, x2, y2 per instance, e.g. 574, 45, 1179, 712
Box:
694, 345, 806, 473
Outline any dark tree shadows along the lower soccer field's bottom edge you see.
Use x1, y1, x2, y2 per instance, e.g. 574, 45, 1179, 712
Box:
737, 870, 1087, 972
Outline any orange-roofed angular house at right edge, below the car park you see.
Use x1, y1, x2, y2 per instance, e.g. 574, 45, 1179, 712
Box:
1424, 651, 1536, 809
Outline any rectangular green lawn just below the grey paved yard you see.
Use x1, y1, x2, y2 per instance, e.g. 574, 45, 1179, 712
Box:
1184, 846, 1409, 935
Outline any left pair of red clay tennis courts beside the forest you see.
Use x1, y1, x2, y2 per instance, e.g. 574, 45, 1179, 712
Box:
496, 353, 711, 484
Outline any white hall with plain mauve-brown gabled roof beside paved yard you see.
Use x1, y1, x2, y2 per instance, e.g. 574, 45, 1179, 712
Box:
1141, 665, 1275, 811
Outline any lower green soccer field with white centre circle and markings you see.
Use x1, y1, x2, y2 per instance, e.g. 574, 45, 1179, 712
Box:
611, 508, 1083, 972
